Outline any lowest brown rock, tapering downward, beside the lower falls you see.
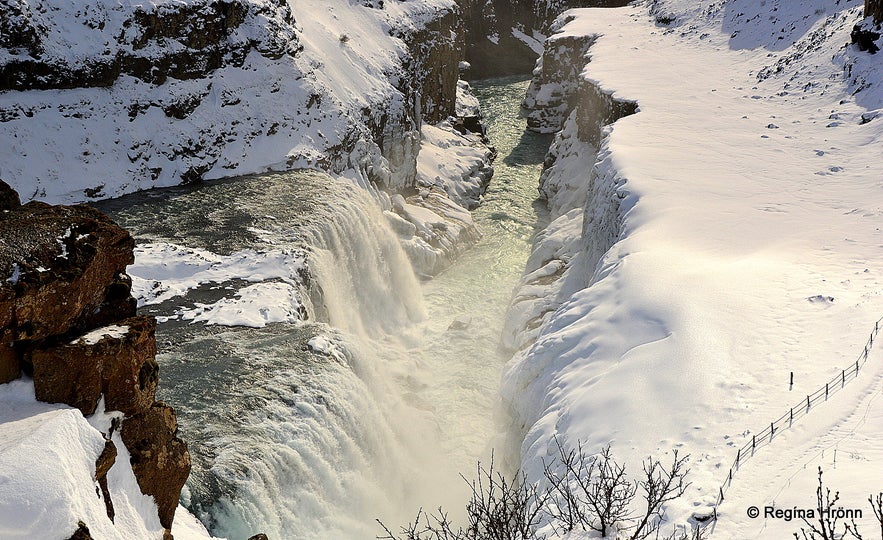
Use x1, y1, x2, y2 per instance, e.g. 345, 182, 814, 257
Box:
120, 402, 190, 529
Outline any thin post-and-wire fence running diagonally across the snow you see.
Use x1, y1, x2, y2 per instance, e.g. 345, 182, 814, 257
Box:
714, 318, 883, 520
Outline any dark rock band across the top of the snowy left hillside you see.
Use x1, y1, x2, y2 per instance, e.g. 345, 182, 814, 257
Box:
0, 0, 299, 90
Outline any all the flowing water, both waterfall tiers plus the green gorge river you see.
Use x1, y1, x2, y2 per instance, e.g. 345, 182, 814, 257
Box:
101, 74, 548, 540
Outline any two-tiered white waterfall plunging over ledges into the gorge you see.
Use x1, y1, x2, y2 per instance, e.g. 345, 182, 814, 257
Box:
129, 172, 459, 540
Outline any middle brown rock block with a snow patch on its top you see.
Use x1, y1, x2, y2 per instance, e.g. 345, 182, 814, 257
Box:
31, 317, 159, 415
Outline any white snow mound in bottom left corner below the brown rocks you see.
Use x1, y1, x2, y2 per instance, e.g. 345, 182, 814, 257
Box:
0, 379, 218, 540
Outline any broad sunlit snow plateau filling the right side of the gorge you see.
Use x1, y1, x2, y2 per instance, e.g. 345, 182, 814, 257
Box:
504, 0, 883, 540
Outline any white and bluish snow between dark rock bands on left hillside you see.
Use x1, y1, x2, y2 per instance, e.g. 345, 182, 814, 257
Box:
0, 0, 454, 203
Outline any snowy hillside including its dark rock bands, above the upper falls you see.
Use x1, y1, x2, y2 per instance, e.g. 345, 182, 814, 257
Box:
0, 0, 460, 202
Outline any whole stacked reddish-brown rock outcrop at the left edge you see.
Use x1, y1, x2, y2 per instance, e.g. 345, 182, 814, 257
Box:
0, 183, 190, 538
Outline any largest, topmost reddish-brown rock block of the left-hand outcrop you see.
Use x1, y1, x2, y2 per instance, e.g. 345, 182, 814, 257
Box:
0, 202, 135, 383
